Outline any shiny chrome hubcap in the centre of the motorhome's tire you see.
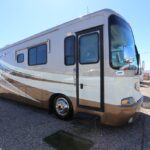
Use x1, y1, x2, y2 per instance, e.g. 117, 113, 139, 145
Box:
56, 98, 69, 116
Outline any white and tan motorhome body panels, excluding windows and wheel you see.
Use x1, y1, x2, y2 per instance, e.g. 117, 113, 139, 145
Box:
0, 9, 142, 125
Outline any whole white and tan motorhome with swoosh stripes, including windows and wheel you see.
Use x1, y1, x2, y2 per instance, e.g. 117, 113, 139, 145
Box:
0, 9, 142, 125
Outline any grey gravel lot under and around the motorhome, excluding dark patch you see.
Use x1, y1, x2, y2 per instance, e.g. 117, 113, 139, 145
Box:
0, 84, 150, 150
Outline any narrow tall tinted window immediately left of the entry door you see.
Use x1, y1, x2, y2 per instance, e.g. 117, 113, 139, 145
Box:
64, 36, 75, 65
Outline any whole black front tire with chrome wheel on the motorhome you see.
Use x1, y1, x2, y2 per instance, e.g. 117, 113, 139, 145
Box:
53, 95, 73, 120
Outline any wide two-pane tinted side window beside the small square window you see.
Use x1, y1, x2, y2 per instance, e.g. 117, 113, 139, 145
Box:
28, 44, 47, 66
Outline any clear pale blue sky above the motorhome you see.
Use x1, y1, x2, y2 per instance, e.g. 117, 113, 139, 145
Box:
0, 0, 150, 70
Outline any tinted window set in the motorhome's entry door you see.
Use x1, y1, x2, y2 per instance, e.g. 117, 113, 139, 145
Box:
79, 32, 99, 64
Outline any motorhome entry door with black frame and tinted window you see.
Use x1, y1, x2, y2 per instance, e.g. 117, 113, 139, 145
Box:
76, 27, 104, 111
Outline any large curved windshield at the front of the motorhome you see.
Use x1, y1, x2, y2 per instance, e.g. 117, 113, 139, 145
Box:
109, 15, 137, 70
